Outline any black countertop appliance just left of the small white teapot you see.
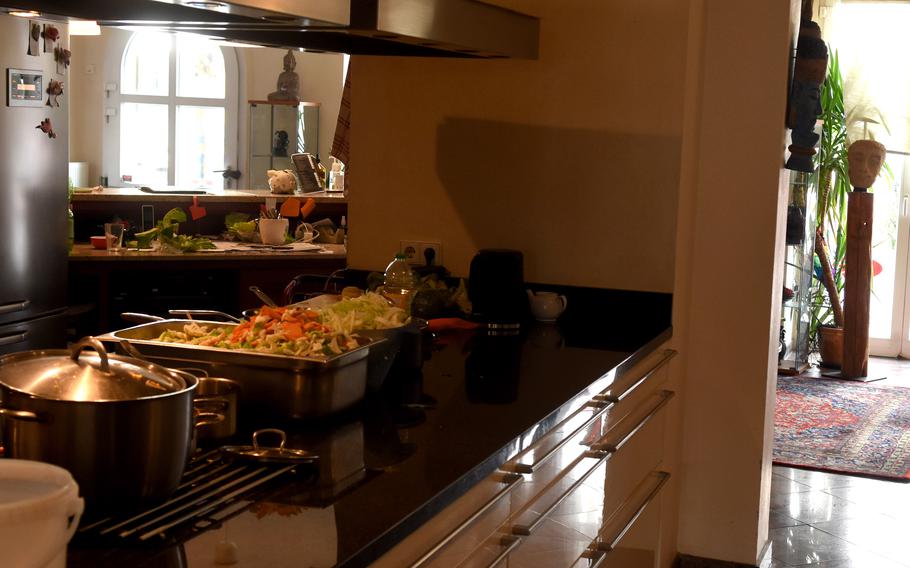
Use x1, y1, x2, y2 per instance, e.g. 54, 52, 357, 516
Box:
468, 249, 528, 330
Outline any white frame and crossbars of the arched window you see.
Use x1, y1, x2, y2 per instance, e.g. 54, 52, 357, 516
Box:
102, 30, 240, 191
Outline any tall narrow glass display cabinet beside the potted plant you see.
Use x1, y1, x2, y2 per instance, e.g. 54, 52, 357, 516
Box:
778, 166, 818, 375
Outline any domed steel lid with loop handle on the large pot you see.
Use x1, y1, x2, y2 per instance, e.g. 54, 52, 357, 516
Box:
0, 337, 187, 402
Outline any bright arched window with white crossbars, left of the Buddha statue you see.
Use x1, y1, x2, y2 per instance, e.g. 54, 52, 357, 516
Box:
105, 31, 238, 190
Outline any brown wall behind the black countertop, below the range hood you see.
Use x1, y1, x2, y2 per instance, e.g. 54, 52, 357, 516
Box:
348, 0, 688, 292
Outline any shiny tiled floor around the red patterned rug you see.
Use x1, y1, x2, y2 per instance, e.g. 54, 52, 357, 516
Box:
770, 358, 910, 568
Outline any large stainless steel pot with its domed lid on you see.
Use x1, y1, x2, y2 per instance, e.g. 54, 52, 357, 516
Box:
0, 338, 210, 510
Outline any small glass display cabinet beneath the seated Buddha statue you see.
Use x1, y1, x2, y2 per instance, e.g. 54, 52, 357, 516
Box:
247, 101, 320, 189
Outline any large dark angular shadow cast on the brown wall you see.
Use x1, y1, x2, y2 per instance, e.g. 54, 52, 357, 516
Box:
436, 118, 681, 291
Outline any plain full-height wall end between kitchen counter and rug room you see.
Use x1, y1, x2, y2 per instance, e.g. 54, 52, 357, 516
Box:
673, 0, 800, 565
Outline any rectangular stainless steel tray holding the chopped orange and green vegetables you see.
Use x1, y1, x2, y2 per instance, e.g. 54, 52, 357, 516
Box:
98, 319, 383, 419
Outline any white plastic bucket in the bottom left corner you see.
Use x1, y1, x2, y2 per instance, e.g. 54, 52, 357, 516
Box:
0, 459, 85, 568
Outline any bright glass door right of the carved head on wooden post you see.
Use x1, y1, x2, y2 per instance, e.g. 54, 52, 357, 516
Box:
869, 152, 910, 357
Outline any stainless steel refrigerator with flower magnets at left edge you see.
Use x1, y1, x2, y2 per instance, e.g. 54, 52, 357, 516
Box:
0, 13, 72, 354
